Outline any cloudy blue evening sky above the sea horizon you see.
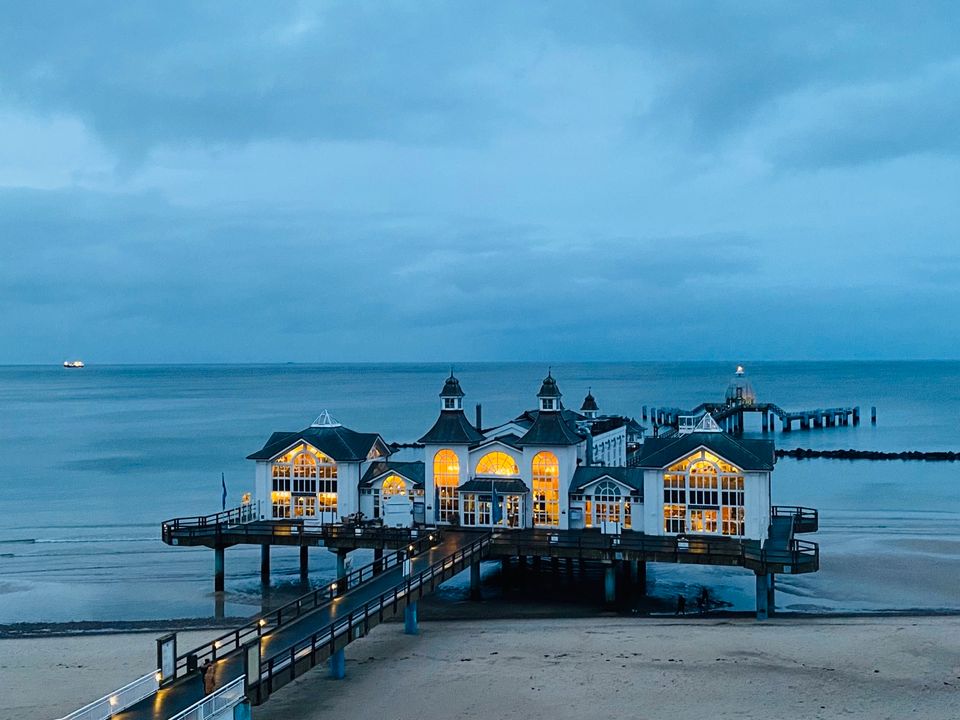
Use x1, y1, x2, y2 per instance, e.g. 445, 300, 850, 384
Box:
0, 0, 960, 364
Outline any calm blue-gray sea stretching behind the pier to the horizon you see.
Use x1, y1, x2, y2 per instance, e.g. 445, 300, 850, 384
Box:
0, 362, 960, 623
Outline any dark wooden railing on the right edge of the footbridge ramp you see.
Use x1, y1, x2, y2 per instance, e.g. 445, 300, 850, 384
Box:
248, 534, 492, 702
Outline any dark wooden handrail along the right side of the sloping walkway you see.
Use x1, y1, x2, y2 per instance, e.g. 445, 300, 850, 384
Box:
251, 534, 493, 690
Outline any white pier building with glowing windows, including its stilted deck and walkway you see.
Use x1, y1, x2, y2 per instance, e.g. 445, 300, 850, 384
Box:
67, 372, 820, 720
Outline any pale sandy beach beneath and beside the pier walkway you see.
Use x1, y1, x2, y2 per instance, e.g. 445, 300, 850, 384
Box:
0, 617, 960, 720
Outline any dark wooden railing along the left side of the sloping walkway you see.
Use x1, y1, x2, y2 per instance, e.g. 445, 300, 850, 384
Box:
175, 530, 442, 676
